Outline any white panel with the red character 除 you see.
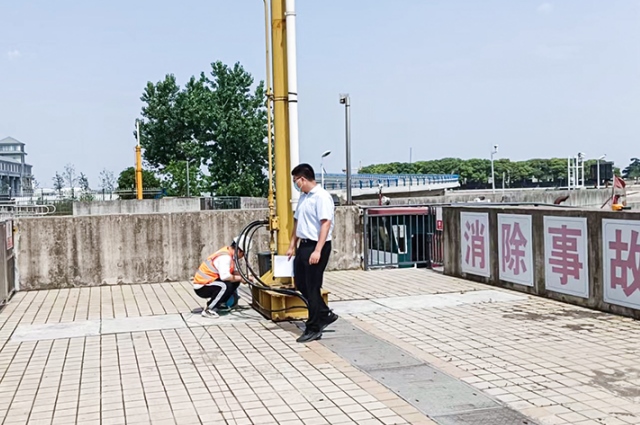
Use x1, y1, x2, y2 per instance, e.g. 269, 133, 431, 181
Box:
498, 214, 533, 286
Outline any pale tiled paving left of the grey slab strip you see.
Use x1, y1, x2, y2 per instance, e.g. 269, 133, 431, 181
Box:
0, 283, 433, 425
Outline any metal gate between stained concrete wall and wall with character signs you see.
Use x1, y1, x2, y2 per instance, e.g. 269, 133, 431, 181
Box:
363, 205, 444, 270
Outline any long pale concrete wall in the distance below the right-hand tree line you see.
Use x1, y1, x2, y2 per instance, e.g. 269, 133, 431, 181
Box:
356, 189, 611, 208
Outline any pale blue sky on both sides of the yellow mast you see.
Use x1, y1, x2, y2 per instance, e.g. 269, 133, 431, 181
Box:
0, 0, 640, 187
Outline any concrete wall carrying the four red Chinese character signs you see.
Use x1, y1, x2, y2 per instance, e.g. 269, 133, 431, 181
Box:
443, 207, 640, 318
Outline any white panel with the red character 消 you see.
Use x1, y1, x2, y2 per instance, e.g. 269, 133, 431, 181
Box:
460, 212, 491, 277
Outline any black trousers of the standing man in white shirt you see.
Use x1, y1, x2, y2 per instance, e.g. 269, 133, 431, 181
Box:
293, 241, 331, 333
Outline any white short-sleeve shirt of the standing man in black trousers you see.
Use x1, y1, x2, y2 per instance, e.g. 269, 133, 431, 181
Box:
293, 185, 335, 241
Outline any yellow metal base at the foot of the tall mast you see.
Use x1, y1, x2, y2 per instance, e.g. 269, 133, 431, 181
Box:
251, 273, 329, 322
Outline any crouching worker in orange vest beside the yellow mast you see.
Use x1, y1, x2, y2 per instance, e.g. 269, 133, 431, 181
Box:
193, 238, 252, 318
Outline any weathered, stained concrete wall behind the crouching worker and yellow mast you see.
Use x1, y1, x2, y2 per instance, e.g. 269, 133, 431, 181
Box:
15, 207, 362, 290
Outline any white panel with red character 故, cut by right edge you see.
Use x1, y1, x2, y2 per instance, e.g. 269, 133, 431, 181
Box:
602, 219, 640, 309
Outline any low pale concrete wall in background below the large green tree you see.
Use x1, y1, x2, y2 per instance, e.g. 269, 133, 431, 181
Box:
73, 198, 200, 216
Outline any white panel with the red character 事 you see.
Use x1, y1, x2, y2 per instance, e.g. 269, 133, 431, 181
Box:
544, 216, 589, 298
